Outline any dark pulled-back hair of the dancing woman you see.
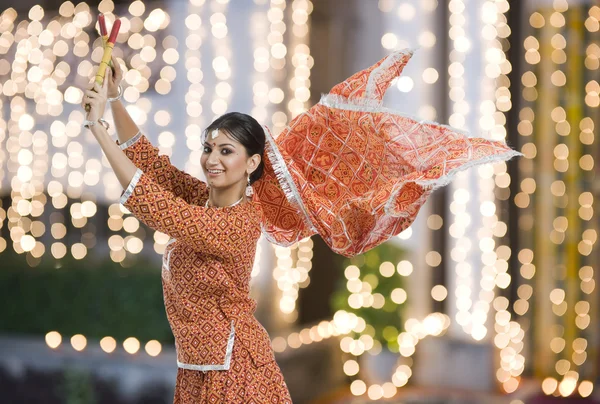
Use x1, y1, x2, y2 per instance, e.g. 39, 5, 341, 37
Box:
204, 112, 265, 184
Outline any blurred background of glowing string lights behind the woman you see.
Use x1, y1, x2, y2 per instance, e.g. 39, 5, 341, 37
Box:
0, 0, 600, 404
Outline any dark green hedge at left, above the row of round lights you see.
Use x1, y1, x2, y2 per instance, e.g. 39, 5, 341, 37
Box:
0, 252, 173, 343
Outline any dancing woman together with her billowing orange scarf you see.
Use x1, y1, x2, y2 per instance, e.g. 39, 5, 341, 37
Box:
82, 50, 519, 403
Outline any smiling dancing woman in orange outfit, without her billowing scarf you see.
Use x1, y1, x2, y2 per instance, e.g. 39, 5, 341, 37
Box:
82, 58, 291, 404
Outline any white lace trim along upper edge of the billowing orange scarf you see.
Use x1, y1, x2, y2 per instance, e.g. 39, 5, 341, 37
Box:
319, 94, 473, 138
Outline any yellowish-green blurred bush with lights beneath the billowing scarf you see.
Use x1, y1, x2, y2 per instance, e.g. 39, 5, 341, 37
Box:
331, 242, 404, 352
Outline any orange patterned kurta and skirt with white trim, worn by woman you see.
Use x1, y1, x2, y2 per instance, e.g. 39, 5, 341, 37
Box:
120, 134, 291, 403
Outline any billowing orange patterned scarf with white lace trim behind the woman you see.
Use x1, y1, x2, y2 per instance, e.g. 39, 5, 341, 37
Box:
255, 50, 520, 257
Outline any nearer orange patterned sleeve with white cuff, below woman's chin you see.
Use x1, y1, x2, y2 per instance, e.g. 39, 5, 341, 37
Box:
120, 169, 248, 254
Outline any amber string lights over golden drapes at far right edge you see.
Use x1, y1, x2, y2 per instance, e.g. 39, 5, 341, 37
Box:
515, 0, 600, 397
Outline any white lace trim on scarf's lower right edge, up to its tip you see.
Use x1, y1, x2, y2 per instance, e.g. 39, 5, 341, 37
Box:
384, 150, 523, 217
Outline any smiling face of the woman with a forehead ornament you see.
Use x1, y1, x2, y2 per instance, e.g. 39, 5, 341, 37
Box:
200, 131, 256, 188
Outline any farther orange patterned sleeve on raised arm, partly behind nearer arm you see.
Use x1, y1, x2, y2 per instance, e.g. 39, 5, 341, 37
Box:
117, 132, 208, 205
